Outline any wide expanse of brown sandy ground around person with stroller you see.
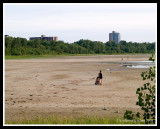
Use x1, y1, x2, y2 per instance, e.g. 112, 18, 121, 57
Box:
4, 54, 151, 120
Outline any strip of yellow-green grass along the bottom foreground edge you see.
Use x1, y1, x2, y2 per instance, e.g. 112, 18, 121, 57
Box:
5, 116, 148, 124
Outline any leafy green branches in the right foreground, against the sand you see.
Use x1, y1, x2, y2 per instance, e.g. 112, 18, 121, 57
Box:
124, 54, 155, 124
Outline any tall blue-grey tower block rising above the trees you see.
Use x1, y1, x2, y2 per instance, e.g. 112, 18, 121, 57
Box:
109, 31, 120, 44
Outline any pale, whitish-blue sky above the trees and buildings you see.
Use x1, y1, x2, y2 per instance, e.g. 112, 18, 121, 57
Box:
3, 3, 157, 43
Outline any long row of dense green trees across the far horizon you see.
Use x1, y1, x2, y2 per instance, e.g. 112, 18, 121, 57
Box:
5, 37, 155, 55
